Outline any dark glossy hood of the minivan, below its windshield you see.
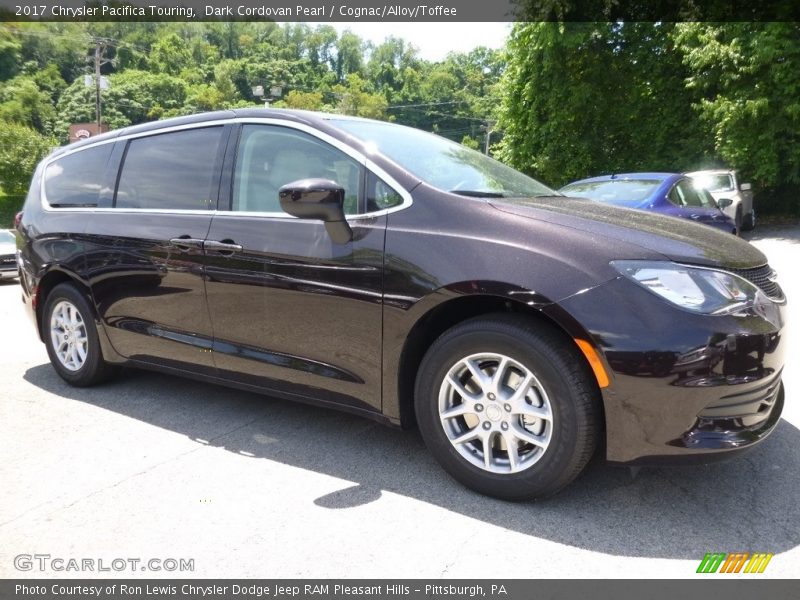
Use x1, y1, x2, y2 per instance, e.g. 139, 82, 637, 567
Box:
490, 196, 767, 269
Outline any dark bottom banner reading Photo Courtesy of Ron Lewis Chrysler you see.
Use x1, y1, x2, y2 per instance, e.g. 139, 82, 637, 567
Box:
0, 576, 800, 600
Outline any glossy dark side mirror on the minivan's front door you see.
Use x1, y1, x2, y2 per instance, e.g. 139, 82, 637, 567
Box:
278, 179, 353, 244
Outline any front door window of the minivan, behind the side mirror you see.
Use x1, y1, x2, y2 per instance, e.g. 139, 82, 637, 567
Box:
231, 125, 362, 215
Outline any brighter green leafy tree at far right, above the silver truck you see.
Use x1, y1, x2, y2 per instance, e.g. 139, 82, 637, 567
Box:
677, 22, 800, 188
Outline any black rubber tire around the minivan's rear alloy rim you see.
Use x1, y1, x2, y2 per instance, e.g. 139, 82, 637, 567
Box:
42, 283, 118, 387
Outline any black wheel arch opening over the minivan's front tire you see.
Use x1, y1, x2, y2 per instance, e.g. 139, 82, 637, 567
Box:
395, 294, 610, 428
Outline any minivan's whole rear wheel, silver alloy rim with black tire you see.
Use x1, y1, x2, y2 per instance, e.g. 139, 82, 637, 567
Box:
42, 283, 116, 386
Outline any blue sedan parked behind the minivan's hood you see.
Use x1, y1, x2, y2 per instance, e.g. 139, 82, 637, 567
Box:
559, 173, 739, 235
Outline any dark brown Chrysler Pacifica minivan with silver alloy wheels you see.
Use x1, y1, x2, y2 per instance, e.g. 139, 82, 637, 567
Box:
19, 109, 785, 499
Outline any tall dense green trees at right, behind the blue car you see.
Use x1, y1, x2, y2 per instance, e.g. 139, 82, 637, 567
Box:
498, 22, 800, 213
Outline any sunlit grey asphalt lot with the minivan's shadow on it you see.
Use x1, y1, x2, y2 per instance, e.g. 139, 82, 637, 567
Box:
0, 226, 800, 578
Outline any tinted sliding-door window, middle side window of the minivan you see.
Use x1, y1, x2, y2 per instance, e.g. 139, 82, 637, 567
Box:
115, 127, 222, 210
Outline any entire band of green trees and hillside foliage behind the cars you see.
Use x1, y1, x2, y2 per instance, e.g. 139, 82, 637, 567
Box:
0, 22, 800, 212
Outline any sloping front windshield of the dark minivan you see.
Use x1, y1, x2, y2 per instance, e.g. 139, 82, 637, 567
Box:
332, 119, 558, 198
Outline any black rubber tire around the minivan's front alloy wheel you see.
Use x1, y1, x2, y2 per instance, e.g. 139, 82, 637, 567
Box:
415, 315, 602, 500
